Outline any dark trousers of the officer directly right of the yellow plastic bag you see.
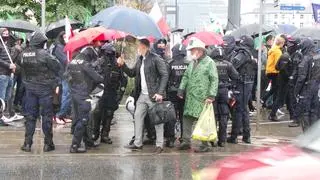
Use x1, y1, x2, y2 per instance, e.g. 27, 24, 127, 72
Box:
214, 88, 230, 142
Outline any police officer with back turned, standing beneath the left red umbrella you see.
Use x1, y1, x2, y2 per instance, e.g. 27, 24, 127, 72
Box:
67, 46, 103, 153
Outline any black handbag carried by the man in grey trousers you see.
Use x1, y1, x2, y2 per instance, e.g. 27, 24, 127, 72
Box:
148, 101, 176, 125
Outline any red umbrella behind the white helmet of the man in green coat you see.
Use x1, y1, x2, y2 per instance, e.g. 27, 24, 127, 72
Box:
183, 31, 223, 46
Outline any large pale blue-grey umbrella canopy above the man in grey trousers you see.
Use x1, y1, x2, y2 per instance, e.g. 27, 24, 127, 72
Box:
90, 6, 163, 39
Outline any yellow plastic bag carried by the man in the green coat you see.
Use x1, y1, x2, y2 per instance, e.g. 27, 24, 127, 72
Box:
192, 104, 217, 141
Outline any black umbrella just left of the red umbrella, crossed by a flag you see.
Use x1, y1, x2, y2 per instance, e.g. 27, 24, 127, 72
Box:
46, 19, 83, 39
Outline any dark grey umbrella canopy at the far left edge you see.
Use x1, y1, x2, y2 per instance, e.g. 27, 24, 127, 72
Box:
0, 19, 40, 32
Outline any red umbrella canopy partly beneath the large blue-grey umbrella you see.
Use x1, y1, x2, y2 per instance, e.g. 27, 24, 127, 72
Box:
64, 27, 126, 53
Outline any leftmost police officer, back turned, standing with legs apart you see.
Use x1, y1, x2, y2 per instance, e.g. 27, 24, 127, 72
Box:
18, 32, 62, 152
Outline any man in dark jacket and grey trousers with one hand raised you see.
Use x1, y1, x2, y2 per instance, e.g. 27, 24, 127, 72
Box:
118, 39, 169, 154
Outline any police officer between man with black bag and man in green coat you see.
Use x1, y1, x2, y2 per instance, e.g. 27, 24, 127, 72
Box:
167, 44, 189, 147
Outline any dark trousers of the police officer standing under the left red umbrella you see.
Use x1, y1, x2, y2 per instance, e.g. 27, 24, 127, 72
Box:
71, 94, 91, 147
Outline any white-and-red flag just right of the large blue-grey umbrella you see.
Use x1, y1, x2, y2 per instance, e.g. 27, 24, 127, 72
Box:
149, 2, 170, 36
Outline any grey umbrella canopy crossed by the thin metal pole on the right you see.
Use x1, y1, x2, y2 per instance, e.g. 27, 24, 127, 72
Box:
230, 24, 276, 38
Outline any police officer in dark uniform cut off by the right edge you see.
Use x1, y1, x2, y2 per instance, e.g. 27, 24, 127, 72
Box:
294, 39, 320, 132
